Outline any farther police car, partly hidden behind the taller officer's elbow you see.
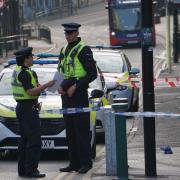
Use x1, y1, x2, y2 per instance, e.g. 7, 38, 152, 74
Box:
91, 46, 140, 111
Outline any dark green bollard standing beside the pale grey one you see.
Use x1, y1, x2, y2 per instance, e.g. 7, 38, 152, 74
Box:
112, 98, 128, 180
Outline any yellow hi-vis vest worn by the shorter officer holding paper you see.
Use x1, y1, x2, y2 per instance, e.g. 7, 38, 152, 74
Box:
11, 66, 38, 100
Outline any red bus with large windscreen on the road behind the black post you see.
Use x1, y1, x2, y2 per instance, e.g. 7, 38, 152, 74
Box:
106, 0, 155, 46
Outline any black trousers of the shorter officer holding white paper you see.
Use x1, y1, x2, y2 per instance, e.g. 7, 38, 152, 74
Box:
16, 103, 41, 175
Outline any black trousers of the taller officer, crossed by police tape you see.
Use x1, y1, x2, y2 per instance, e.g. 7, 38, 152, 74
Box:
62, 91, 92, 168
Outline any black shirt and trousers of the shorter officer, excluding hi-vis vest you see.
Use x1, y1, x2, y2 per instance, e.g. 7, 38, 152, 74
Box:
15, 47, 41, 176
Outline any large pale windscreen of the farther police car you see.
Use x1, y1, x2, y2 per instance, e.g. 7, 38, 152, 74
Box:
93, 53, 123, 73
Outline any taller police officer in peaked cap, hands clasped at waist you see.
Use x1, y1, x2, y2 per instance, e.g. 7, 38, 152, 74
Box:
58, 23, 97, 173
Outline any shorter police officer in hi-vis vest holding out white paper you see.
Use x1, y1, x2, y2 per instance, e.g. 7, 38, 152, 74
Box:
11, 47, 54, 178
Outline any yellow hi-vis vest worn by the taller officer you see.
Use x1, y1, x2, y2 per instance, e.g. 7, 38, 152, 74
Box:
58, 41, 87, 80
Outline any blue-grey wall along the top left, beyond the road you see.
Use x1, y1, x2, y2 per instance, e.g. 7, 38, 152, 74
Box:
21, 0, 104, 21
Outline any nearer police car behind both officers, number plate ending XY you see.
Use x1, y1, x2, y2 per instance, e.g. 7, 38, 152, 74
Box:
0, 60, 103, 157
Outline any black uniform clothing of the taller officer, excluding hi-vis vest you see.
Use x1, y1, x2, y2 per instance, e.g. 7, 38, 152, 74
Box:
60, 24, 97, 171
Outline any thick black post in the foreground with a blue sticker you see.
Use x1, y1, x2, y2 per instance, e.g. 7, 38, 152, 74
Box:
141, 0, 156, 176
